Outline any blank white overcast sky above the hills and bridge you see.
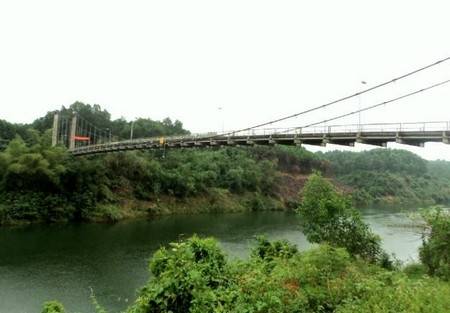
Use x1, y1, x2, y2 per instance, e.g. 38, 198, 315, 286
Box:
0, 0, 450, 159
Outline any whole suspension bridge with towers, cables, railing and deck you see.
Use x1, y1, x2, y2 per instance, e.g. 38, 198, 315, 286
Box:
52, 57, 450, 156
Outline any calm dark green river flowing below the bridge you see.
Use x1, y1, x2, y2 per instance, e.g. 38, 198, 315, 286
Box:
0, 210, 421, 313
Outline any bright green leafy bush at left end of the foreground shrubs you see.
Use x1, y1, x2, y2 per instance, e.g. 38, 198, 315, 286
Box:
128, 236, 227, 313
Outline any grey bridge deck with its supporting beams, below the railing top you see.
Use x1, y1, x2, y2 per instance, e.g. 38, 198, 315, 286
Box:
69, 130, 450, 156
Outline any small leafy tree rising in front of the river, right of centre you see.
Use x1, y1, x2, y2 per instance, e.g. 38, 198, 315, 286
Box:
296, 173, 382, 261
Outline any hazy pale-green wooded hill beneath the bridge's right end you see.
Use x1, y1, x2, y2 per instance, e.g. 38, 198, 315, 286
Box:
324, 148, 450, 205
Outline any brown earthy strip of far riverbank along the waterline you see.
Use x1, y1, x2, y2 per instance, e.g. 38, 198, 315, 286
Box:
0, 169, 442, 226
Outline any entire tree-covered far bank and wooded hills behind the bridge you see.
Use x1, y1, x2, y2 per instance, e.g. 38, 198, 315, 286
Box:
0, 102, 450, 224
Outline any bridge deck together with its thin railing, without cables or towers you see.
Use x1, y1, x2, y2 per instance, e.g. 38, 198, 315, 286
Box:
69, 122, 450, 156
